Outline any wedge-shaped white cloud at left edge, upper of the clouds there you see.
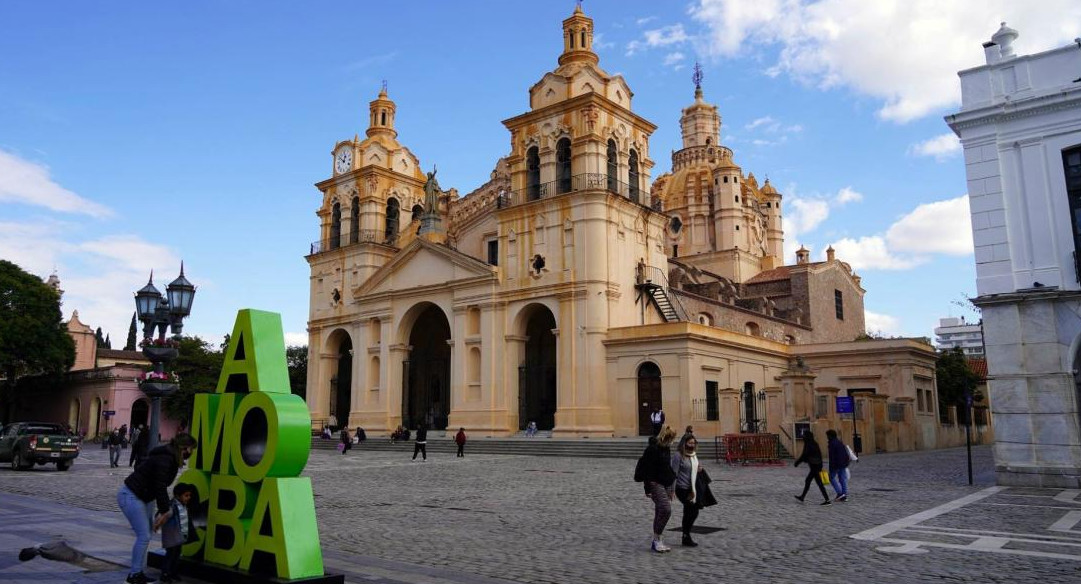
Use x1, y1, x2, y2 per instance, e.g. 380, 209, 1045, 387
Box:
0, 150, 112, 217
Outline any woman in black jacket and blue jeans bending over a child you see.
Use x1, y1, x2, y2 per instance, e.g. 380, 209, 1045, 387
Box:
117, 434, 197, 584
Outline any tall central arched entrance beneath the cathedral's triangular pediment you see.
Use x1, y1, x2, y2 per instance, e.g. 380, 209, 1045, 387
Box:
402, 304, 451, 429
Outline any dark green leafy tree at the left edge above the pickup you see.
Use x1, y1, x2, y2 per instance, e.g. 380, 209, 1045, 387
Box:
0, 260, 75, 419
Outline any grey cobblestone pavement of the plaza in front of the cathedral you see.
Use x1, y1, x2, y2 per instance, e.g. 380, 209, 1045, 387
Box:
0, 447, 1081, 584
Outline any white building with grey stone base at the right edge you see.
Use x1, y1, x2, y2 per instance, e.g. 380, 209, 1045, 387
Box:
946, 24, 1081, 489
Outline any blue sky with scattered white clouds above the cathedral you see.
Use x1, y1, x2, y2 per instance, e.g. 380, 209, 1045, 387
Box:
0, 0, 1081, 347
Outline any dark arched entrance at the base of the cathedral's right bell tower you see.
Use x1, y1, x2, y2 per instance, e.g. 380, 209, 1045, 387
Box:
518, 306, 556, 430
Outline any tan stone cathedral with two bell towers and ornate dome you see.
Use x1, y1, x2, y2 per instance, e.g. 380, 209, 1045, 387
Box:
306, 6, 972, 452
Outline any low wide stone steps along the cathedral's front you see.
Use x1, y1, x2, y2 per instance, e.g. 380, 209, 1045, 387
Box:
311, 432, 724, 460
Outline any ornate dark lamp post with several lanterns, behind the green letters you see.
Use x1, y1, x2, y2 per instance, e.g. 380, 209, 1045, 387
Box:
135, 262, 196, 449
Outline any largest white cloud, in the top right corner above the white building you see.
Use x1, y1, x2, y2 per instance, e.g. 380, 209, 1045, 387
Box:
691, 0, 1081, 122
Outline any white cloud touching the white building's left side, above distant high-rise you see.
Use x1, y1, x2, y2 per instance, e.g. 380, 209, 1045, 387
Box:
885, 195, 973, 255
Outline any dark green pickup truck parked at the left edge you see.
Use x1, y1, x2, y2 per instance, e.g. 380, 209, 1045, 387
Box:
0, 422, 79, 470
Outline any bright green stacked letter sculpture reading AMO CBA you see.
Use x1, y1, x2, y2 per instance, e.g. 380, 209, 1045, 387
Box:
179, 309, 323, 580
